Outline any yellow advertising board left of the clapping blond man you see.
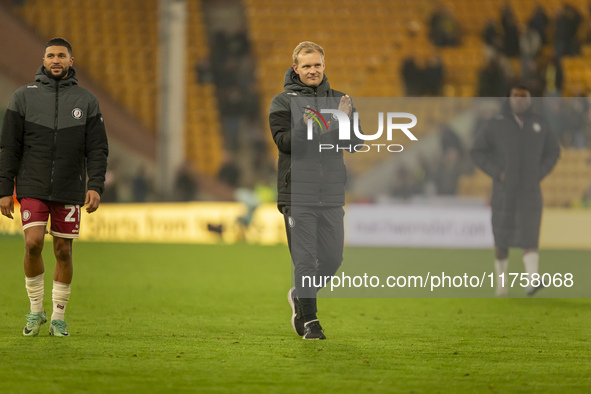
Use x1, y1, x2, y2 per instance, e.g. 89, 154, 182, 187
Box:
0, 202, 287, 245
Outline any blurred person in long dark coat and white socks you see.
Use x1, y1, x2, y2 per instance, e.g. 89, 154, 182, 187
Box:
470, 86, 560, 296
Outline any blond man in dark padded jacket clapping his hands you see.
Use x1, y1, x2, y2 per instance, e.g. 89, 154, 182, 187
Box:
269, 41, 363, 339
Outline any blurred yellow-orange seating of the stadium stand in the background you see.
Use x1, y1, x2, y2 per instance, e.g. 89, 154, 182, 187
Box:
6, 0, 591, 206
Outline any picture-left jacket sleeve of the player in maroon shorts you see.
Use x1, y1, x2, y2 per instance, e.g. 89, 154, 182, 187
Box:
0, 93, 25, 197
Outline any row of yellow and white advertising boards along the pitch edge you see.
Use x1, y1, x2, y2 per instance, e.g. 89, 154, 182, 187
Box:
0, 202, 591, 250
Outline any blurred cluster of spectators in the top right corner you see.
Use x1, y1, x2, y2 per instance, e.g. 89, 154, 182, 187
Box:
478, 3, 591, 97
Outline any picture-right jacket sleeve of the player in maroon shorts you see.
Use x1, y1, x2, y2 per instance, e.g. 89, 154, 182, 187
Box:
85, 99, 109, 194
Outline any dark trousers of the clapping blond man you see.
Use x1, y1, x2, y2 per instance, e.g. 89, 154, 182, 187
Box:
283, 206, 345, 316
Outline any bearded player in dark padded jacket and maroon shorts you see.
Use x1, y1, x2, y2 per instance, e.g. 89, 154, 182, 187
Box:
0, 38, 108, 337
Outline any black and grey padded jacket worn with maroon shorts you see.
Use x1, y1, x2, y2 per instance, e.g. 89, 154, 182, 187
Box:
0, 66, 108, 205
